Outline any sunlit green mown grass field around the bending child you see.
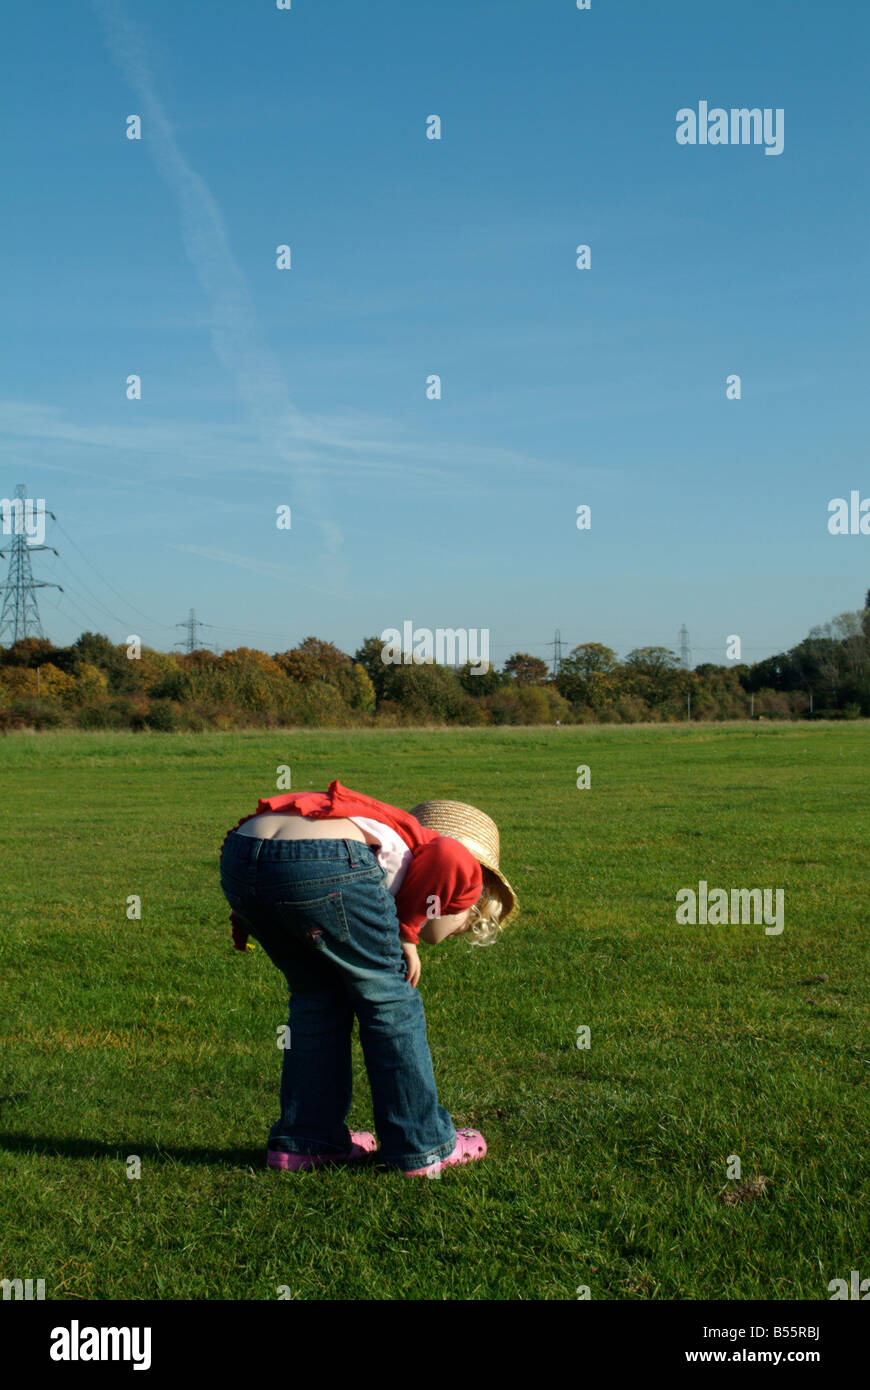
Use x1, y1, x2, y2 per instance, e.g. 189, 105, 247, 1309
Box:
0, 723, 870, 1300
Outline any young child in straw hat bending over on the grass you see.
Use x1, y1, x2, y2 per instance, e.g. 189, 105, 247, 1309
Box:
221, 781, 518, 1176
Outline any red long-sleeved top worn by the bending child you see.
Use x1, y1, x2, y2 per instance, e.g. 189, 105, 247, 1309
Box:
224, 781, 484, 951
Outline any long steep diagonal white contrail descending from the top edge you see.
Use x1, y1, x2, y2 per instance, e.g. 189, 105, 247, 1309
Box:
92, 0, 342, 555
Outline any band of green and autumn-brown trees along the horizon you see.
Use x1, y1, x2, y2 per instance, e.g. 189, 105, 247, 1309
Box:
0, 591, 870, 731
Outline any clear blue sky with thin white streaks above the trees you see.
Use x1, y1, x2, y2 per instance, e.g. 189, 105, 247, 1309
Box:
0, 0, 870, 663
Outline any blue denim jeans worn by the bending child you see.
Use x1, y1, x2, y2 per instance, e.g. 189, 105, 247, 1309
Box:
221, 831, 456, 1168
